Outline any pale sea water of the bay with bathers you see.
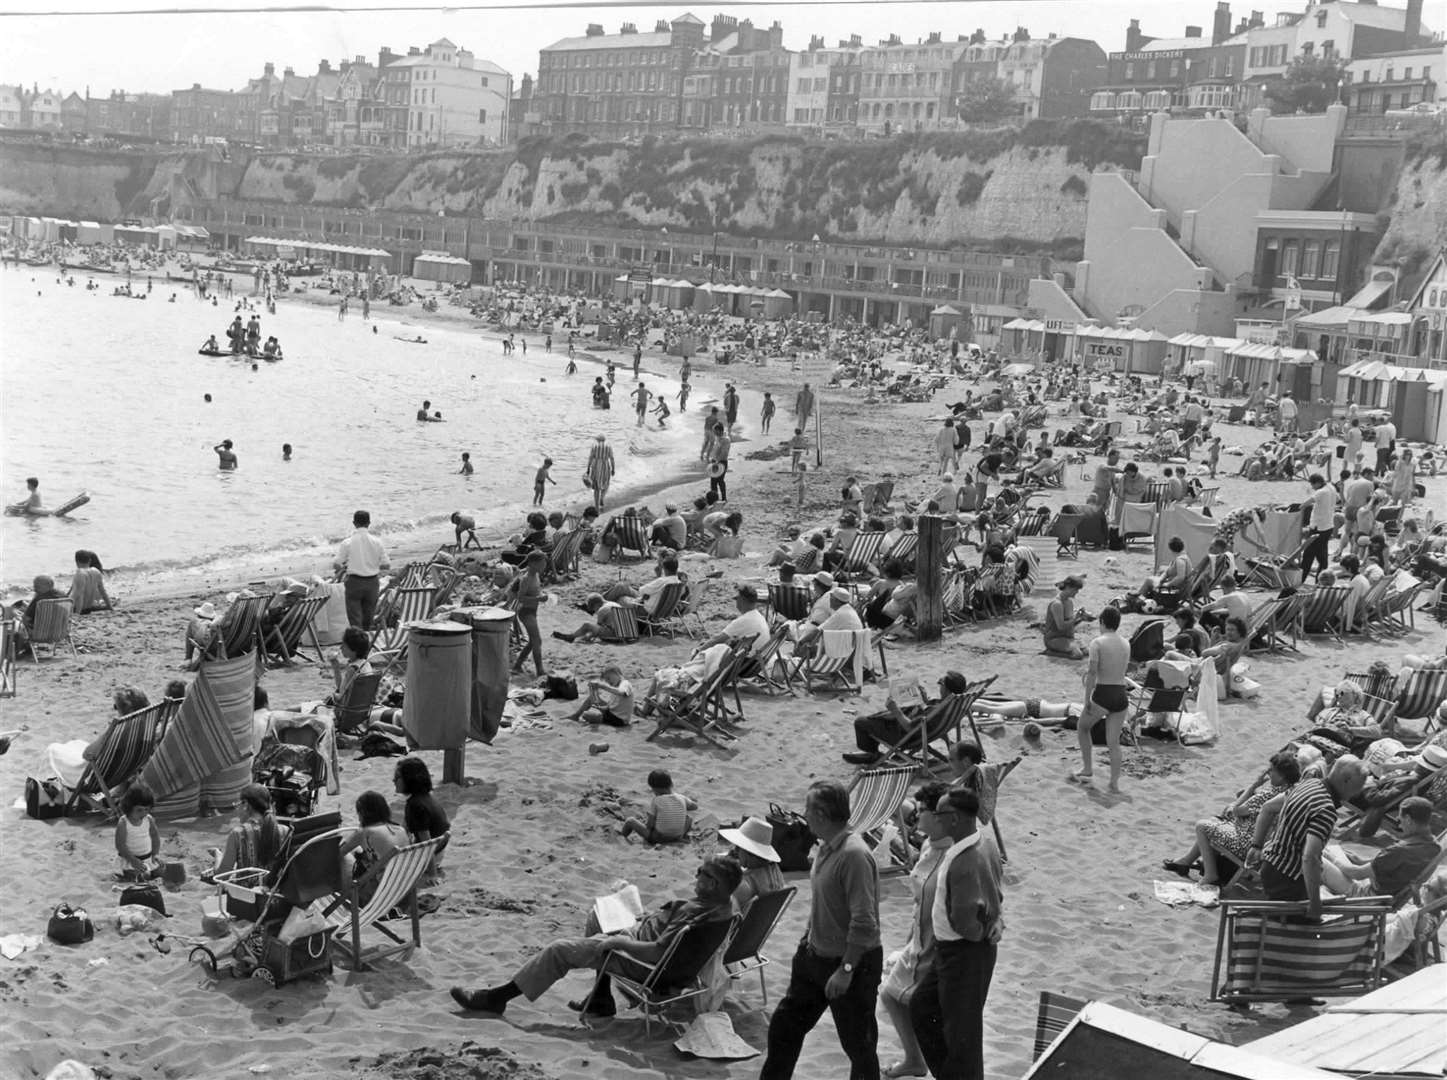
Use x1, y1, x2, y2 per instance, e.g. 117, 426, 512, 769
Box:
0, 266, 706, 589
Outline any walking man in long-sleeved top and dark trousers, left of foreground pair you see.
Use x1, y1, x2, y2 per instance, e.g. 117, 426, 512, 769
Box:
758, 780, 884, 1080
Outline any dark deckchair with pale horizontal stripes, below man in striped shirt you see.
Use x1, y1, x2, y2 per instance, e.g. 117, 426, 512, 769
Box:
1210, 896, 1392, 1003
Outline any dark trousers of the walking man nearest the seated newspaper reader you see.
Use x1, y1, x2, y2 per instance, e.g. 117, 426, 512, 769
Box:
758, 941, 884, 1080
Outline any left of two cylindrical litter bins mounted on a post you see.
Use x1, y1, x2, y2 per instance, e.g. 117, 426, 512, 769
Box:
402, 620, 472, 750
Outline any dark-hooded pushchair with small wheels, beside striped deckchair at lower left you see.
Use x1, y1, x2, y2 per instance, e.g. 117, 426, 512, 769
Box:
188, 814, 343, 986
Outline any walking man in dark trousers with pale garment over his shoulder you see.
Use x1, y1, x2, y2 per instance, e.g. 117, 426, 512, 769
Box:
910, 788, 1004, 1080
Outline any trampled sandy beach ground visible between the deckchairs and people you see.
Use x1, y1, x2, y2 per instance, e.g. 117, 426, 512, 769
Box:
0, 279, 1447, 1080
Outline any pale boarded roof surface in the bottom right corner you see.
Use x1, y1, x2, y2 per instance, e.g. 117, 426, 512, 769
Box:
1242, 964, 1447, 1077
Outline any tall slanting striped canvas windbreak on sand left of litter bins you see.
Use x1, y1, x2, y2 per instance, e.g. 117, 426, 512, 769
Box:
140, 642, 256, 817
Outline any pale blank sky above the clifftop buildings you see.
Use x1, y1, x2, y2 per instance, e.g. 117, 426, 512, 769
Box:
0, 0, 1232, 96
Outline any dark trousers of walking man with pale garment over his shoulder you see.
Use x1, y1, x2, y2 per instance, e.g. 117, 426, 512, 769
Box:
910, 941, 998, 1080
